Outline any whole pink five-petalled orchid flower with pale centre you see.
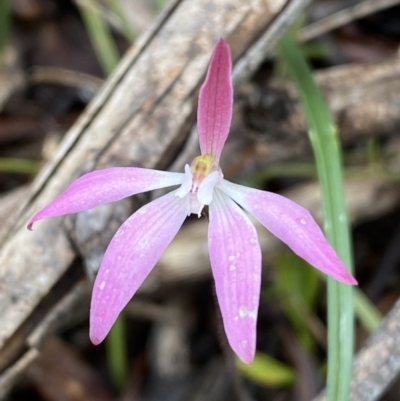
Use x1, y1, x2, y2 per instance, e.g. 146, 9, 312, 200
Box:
28, 39, 357, 363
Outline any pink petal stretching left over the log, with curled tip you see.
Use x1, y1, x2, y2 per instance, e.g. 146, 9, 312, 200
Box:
28, 167, 183, 229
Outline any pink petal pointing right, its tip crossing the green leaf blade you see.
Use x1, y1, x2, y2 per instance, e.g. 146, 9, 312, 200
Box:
218, 180, 357, 285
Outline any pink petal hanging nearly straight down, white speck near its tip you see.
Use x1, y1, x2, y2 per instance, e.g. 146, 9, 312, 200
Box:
208, 189, 261, 363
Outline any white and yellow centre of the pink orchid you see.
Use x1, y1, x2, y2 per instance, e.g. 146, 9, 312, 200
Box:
176, 154, 223, 217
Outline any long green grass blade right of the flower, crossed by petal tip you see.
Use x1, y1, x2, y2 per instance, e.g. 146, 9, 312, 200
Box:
278, 34, 354, 401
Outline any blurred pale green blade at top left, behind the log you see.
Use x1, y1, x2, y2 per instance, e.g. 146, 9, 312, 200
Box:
77, 0, 119, 75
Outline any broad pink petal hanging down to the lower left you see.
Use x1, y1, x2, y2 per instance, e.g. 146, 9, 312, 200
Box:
90, 191, 187, 345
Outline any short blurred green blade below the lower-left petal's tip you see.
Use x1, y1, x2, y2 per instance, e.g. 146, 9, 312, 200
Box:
106, 314, 129, 390
